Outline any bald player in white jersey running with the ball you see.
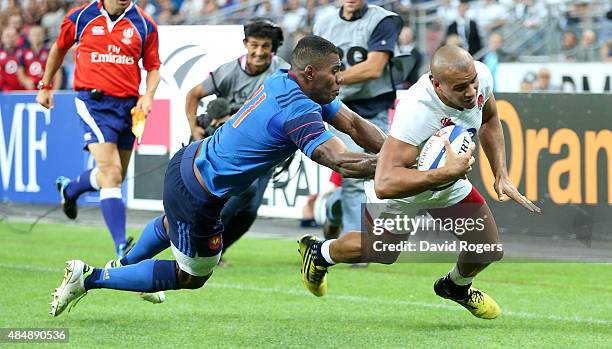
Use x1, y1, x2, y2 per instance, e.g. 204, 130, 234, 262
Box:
299, 46, 540, 319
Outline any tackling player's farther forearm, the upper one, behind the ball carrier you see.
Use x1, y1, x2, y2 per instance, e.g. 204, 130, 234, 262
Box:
330, 104, 387, 154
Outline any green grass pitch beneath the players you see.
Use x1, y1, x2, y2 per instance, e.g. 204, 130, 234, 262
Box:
0, 223, 612, 348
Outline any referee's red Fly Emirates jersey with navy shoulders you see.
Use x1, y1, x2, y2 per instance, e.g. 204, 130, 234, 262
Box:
57, 0, 160, 97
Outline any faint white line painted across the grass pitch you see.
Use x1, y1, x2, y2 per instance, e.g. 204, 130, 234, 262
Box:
0, 263, 612, 326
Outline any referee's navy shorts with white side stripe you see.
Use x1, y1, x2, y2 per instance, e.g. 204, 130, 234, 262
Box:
74, 91, 138, 150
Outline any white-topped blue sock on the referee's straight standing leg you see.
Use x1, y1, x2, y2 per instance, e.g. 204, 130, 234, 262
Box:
100, 188, 125, 249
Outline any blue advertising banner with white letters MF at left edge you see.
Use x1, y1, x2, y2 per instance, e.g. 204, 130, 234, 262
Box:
0, 92, 98, 204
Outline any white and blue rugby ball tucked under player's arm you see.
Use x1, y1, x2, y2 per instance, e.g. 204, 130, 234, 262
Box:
418, 125, 472, 191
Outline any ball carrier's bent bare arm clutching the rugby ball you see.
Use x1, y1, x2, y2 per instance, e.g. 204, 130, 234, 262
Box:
374, 136, 474, 199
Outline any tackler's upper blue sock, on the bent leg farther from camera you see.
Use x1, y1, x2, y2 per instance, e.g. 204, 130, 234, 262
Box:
121, 216, 170, 265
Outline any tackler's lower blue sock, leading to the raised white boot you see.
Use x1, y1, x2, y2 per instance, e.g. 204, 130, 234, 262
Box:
84, 259, 177, 292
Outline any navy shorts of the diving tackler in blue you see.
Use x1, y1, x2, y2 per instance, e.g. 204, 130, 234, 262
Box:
163, 141, 227, 258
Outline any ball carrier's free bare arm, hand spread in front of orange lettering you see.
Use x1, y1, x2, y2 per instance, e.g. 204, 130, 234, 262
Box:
478, 95, 541, 213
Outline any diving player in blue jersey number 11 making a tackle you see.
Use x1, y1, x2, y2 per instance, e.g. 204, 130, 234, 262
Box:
50, 36, 385, 316
